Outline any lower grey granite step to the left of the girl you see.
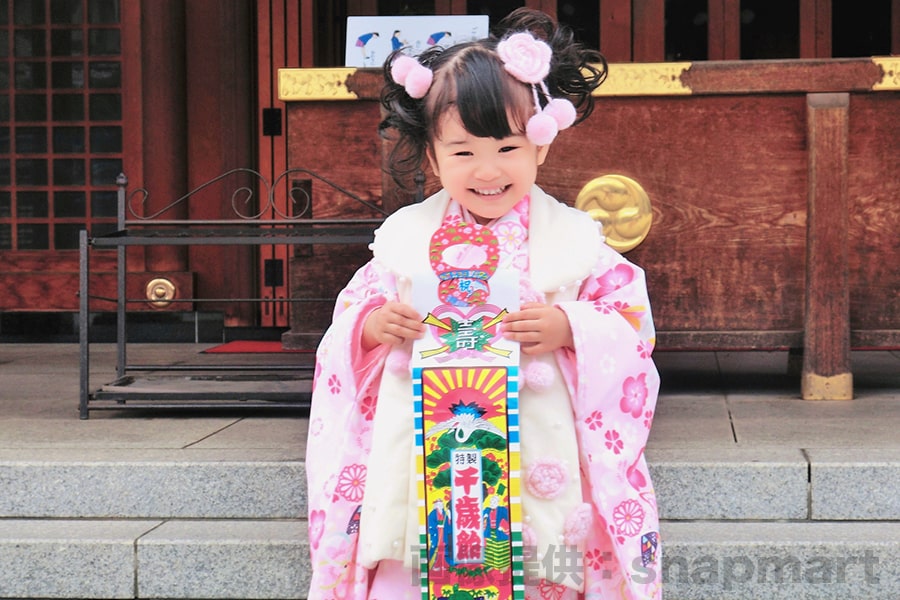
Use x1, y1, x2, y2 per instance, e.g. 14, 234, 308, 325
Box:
0, 519, 309, 600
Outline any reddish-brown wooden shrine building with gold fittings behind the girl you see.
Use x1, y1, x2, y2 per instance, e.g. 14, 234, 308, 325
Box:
0, 0, 900, 398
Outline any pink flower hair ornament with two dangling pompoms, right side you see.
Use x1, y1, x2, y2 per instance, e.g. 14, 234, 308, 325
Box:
497, 31, 577, 146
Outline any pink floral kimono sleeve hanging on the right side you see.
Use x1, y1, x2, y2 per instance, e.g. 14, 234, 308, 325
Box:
559, 248, 661, 599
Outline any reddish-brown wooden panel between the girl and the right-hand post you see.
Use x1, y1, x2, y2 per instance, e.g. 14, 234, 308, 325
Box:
539, 95, 806, 331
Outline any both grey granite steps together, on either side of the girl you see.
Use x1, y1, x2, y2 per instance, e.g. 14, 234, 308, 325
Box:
0, 447, 900, 600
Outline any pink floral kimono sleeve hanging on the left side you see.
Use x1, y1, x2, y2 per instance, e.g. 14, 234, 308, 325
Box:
306, 261, 396, 600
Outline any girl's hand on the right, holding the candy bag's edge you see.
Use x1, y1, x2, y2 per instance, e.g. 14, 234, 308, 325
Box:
503, 302, 574, 354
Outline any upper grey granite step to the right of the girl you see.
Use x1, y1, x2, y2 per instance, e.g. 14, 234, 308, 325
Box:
647, 446, 900, 521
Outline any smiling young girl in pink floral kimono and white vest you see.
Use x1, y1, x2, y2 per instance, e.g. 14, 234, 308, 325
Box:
307, 9, 661, 600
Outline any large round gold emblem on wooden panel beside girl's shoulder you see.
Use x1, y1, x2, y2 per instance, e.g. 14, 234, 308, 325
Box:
575, 174, 653, 252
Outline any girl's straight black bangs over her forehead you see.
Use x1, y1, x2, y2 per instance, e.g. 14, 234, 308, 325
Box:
429, 47, 534, 139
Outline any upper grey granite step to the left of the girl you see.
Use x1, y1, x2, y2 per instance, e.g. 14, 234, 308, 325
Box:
0, 449, 306, 519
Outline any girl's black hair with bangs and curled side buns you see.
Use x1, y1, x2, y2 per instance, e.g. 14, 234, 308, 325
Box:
378, 8, 607, 189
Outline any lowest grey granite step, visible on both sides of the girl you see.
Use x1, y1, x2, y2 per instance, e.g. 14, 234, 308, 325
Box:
0, 519, 900, 600
